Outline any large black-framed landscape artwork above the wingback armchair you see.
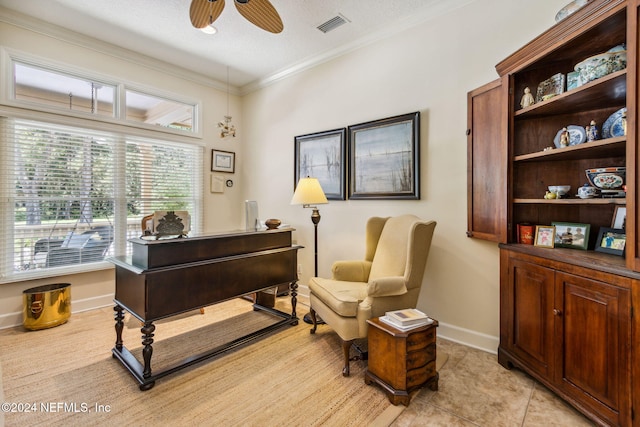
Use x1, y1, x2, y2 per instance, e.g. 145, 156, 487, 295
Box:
349, 112, 420, 200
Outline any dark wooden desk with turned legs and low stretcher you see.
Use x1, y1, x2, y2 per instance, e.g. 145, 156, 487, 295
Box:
110, 229, 301, 390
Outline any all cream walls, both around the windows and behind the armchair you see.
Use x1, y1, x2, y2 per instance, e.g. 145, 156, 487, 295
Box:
0, 0, 568, 352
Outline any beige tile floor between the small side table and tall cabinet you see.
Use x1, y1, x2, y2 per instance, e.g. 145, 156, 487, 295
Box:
391, 338, 595, 427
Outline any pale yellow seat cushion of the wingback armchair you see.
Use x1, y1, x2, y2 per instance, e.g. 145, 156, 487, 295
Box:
309, 277, 367, 317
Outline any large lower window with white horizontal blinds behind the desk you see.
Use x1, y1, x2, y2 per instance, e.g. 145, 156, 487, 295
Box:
0, 117, 203, 282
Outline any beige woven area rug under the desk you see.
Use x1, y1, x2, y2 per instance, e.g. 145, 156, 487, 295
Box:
0, 299, 442, 426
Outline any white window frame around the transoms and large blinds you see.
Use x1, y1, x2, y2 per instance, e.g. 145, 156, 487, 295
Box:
0, 47, 205, 284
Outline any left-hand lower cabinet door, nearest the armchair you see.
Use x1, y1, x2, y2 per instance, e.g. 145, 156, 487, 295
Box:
500, 254, 555, 378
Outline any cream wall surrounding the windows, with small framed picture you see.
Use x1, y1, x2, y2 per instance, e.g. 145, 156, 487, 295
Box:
0, 17, 244, 328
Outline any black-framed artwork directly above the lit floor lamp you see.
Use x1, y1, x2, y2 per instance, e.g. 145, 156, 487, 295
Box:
293, 128, 347, 200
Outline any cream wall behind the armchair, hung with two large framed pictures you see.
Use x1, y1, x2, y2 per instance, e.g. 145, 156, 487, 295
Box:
242, 0, 566, 352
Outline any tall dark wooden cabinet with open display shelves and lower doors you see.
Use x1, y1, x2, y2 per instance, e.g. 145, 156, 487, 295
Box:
467, 0, 640, 425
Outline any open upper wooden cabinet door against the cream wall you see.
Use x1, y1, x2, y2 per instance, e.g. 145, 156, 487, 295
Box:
467, 79, 508, 243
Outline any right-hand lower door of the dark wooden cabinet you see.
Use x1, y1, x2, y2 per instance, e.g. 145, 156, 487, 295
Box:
554, 272, 631, 425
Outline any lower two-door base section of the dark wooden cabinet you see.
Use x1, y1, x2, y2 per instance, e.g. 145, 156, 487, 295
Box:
498, 249, 638, 425
